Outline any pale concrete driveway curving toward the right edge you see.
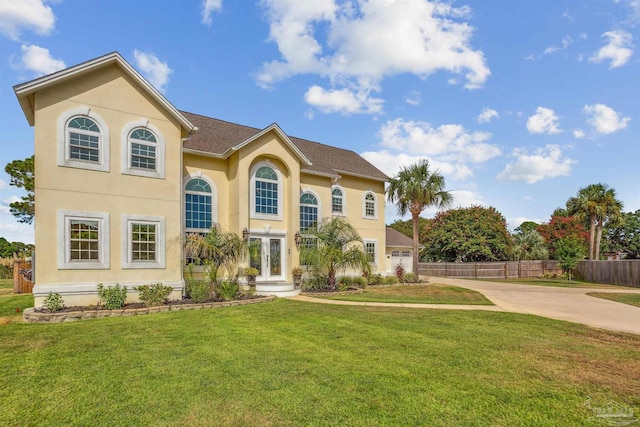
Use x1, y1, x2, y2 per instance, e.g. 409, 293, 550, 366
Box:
430, 277, 640, 335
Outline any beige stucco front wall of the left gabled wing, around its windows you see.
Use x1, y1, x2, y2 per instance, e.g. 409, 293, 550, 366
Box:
35, 65, 183, 305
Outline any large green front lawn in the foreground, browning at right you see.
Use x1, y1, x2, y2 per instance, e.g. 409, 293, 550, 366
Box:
0, 300, 640, 426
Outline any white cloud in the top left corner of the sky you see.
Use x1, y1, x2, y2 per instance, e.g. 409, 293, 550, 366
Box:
0, 0, 56, 41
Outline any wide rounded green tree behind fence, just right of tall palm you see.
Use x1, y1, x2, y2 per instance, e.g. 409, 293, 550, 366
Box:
423, 206, 513, 262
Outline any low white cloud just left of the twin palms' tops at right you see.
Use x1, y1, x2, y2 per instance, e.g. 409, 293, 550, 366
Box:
496, 145, 576, 184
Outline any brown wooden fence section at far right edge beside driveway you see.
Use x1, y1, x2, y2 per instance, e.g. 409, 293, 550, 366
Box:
576, 259, 640, 287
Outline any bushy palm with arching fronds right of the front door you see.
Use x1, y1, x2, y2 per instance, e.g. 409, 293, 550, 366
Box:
300, 217, 371, 290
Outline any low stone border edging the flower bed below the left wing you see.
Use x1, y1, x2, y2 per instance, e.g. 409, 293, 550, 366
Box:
22, 296, 276, 323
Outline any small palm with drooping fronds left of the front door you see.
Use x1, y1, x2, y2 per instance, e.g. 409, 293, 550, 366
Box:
185, 224, 247, 284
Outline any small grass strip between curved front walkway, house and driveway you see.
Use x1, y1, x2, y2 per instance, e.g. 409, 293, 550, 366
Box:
321, 283, 493, 305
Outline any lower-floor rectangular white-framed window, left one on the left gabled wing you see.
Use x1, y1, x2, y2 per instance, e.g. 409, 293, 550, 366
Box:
57, 210, 109, 270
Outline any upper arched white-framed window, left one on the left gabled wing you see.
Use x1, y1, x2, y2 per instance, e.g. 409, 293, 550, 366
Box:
58, 107, 109, 172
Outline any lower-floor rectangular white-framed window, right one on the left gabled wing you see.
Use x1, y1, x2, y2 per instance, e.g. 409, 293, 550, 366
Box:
122, 215, 165, 268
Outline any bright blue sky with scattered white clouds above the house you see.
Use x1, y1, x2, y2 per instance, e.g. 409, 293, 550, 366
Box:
0, 0, 640, 242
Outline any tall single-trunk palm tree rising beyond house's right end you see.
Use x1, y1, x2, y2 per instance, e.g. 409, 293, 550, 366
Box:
387, 160, 453, 274
